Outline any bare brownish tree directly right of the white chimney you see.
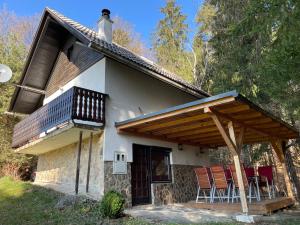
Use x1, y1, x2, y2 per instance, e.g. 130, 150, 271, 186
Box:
113, 16, 147, 55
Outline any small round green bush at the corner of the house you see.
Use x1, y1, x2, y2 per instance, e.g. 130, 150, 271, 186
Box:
100, 190, 125, 219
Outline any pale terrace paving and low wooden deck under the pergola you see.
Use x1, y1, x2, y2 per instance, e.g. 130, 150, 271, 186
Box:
126, 198, 300, 224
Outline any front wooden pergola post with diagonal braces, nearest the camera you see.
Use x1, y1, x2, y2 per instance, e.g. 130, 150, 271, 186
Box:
204, 108, 249, 214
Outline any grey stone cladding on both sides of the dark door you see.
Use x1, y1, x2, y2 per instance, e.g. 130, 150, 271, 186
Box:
104, 161, 197, 207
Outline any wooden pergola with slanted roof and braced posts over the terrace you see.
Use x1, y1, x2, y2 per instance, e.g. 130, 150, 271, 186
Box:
116, 91, 299, 213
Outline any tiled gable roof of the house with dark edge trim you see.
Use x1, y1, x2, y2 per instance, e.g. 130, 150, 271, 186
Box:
9, 8, 210, 111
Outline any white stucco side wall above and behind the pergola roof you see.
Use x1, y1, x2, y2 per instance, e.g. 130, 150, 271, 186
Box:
103, 59, 208, 165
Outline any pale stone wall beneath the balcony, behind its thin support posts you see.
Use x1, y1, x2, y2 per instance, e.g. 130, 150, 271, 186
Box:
35, 135, 104, 199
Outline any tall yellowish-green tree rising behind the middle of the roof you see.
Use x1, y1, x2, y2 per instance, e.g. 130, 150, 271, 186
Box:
153, 0, 193, 81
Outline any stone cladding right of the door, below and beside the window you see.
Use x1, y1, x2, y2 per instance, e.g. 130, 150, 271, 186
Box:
151, 165, 197, 205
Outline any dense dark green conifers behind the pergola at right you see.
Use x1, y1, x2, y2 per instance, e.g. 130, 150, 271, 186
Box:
205, 0, 300, 197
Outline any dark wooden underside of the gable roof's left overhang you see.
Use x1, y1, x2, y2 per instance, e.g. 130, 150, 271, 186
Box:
8, 10, 67, 114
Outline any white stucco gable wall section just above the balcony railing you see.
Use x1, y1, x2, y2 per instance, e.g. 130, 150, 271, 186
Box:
43, 58, 105, 105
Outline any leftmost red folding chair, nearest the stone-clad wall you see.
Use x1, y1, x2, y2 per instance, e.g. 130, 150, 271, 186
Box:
194, 167, 213, 203
